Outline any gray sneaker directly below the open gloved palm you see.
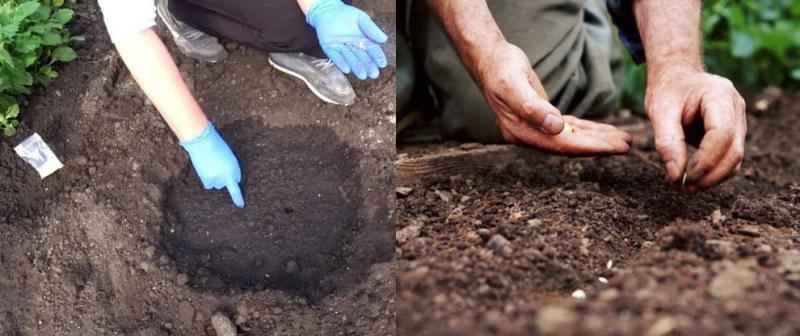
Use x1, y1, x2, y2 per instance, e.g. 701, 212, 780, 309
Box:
269, 52, 356, 105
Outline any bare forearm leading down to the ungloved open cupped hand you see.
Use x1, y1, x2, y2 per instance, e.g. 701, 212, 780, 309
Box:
428, 0, 505, 80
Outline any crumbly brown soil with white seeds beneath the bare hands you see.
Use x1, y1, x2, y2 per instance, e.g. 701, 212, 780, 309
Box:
396, 94, 800, 335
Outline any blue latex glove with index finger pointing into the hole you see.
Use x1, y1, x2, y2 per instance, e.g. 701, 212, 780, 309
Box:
180, 123, 244, 208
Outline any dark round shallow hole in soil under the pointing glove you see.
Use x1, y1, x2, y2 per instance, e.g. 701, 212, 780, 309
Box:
164, 121, 361, 298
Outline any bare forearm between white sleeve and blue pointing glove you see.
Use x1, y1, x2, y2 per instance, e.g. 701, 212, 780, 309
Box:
116, 29, 208, 140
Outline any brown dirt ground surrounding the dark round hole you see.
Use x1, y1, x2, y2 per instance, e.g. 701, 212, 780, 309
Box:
0, 0, 395, 335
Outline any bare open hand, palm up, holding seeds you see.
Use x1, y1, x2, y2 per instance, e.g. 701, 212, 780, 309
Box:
474, 42, 631, 156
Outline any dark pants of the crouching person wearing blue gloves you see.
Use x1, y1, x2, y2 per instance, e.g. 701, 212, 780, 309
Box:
169, 0, 325, 58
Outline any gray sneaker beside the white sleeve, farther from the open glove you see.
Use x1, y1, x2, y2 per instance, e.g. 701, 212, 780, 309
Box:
156, 0, 228, 63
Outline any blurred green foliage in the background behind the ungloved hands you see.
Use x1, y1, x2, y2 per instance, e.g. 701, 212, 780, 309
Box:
624, 0, 800, 108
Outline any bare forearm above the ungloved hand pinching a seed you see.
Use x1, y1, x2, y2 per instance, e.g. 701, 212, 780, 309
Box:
633, 0, 703, 72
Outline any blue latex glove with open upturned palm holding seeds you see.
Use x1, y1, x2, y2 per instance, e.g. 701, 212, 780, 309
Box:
306, 0, 388, 79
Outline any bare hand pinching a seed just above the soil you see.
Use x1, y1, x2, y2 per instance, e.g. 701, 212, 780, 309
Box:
645, 64, 747, 192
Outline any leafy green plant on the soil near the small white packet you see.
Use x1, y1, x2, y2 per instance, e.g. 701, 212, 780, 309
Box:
0, 0, 77, 136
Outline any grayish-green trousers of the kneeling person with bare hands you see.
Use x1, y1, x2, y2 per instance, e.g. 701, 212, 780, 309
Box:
406, 0, 622, 142
